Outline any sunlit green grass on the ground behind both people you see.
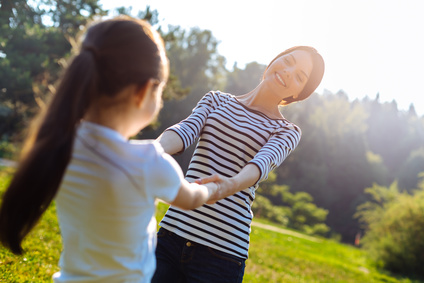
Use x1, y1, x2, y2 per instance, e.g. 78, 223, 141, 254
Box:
0, 168, 422, 283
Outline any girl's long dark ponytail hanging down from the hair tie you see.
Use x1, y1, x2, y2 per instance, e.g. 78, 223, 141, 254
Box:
0, 50, 98, 254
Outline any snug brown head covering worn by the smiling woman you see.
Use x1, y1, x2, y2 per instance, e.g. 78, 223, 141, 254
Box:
264, 46, 325, 105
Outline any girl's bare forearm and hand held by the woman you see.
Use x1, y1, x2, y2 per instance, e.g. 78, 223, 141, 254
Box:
171, 180, 220, 210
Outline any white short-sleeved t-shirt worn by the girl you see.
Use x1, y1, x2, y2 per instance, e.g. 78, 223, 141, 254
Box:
53, 122, 184, 282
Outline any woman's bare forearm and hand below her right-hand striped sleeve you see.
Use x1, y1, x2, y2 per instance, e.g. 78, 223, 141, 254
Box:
197, 163, 261, 204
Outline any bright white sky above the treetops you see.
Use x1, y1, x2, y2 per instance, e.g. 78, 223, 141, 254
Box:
100, 0, 424, 115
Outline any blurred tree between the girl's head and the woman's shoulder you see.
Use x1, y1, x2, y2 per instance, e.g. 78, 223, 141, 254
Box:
140, 26, 226, 162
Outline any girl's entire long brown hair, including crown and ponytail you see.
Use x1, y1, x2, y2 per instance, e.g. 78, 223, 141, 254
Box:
0, 17, 167, 254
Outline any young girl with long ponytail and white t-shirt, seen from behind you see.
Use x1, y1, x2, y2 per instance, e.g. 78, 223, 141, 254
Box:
0, 17, 217, 282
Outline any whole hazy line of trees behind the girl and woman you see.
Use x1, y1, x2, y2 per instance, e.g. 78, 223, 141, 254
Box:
0, 0, 424, 253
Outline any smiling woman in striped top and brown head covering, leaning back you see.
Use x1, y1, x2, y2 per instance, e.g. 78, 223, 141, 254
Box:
152, 46, 324, 282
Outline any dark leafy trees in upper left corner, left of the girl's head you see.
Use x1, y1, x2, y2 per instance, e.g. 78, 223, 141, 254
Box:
0, 0, 105, 141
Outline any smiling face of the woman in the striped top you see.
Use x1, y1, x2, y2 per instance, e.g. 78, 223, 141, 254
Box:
264, 50, 313, 101
